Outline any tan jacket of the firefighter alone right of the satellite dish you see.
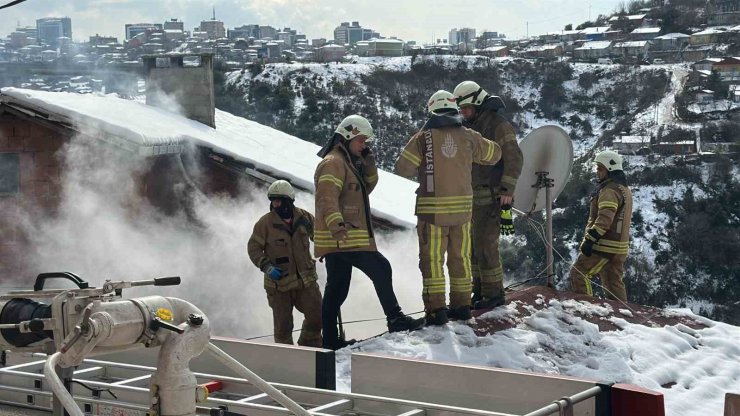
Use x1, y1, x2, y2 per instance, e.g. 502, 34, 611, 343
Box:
586, 173, 632, 254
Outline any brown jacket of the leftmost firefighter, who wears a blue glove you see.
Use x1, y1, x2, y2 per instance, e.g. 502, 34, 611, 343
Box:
247, 207, 317, 292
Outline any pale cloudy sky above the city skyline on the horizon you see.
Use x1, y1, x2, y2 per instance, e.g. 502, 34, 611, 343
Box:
5, 0, 626, 43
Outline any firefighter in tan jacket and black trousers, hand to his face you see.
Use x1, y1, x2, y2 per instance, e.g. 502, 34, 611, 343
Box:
314, 115, 424, 350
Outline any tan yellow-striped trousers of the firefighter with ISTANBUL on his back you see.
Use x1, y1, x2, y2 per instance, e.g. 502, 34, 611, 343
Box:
416, 220, 472, 313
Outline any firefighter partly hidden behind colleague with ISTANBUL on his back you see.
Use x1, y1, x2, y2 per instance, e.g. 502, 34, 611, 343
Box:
453, 81, 523, 309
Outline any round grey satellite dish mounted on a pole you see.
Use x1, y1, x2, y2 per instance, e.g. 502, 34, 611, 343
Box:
514, 126, 573, 214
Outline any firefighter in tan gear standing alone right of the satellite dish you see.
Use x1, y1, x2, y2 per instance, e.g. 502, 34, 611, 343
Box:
570, 150, 632, 302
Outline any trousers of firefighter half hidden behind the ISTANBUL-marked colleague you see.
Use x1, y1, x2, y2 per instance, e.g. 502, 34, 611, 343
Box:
472, 200, 504, 298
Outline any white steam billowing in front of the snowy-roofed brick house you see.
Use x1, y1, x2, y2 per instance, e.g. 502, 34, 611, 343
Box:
22, 135, 422, 342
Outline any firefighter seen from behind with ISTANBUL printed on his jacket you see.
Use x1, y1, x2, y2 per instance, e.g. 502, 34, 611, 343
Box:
396, 91, 501, 325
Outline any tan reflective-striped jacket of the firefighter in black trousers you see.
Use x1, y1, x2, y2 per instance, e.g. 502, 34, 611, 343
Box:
314, 143, 378, 257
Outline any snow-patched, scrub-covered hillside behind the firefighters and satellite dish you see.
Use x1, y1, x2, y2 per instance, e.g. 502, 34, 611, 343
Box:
217, 56, 740, 323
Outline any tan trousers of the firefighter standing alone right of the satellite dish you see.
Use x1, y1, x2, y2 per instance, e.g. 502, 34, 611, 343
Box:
570, 252, 627, 302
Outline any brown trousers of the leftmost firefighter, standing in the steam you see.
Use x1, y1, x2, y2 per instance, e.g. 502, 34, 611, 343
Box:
266, 280, 321, 348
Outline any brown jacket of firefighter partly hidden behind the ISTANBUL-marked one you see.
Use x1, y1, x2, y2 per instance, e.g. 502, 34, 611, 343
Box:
469, 96, 524, 205
